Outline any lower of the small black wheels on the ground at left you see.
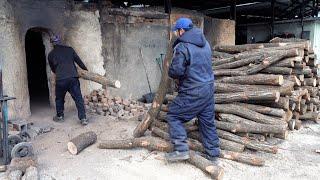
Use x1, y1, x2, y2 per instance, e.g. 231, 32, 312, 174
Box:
11, 142, 33, 159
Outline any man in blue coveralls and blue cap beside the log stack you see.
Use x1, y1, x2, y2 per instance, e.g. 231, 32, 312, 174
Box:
166, 18, 220, 161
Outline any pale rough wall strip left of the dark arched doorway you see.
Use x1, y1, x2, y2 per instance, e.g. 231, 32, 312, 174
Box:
0, 0, 30, 118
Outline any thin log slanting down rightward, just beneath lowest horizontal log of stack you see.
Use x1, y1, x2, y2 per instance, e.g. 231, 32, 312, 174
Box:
217, 129, 278, 154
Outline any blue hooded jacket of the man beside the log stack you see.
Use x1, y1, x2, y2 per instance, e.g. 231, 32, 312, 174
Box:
169, 28, 214, 94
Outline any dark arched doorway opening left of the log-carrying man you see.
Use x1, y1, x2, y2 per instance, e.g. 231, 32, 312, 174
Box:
25, 30, 50, 112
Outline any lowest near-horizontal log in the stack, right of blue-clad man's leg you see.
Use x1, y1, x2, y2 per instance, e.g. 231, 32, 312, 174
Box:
216, 121, 287, 134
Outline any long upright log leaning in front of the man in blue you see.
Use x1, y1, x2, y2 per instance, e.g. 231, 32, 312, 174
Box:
133, 39, 173, 137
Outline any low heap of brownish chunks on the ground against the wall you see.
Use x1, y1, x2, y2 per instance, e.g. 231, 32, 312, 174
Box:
84, 89, 150, 119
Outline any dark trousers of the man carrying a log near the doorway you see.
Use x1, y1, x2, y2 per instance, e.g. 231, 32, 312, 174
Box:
56, 78, 86, 120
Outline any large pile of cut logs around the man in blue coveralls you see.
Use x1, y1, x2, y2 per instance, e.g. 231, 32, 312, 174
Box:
99, 38, 320, 179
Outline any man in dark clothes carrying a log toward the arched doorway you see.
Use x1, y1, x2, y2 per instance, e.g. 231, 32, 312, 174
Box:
48, 36, 88, 125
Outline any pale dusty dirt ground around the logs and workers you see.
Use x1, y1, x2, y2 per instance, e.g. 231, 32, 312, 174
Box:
0, 106, 320, 180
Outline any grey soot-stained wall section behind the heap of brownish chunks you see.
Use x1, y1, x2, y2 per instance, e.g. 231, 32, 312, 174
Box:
101, 9, 168, 98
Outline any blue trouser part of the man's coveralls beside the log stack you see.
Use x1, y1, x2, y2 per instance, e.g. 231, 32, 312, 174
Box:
167, 84, 220, 157
